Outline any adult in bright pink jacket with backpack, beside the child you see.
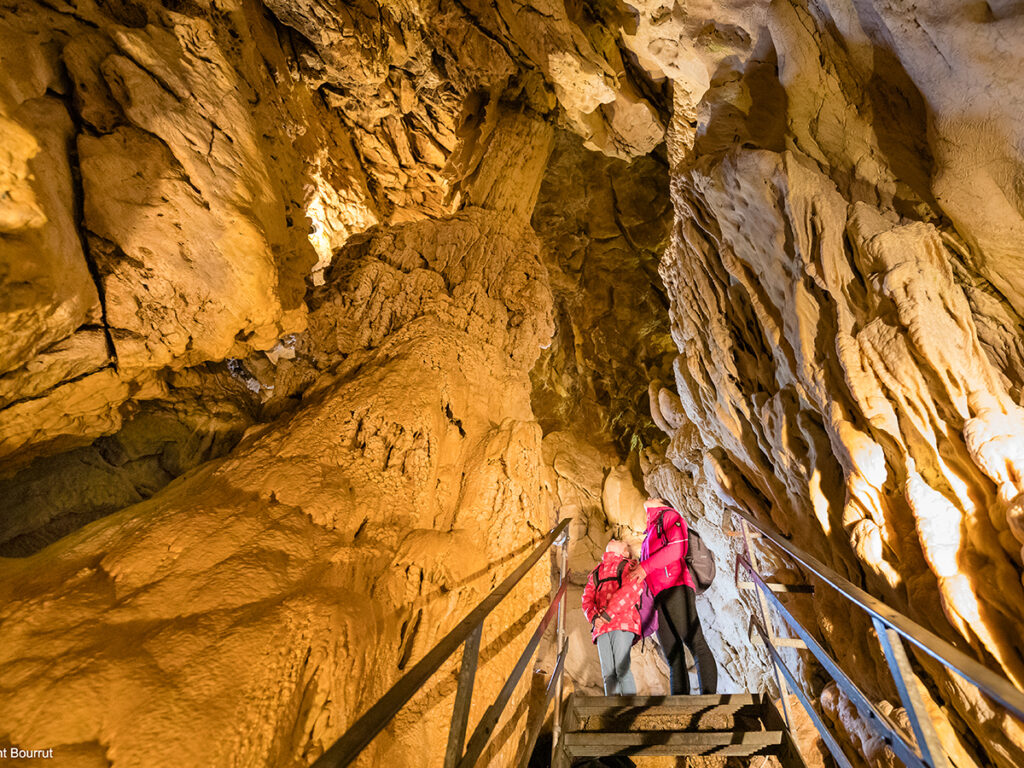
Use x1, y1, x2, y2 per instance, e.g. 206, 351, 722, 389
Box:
630, 499, 718, 695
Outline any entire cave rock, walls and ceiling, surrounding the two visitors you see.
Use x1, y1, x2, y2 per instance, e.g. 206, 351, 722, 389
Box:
0, 0, 1024, 768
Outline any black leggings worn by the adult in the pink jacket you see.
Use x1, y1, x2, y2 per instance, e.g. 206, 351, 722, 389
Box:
654, 585, 718, 695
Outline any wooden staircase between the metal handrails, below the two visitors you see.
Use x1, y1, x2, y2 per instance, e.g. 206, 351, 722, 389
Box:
554, 693, 806, 768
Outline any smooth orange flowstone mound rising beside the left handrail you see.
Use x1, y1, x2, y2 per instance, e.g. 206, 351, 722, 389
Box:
0, 192, 552, 766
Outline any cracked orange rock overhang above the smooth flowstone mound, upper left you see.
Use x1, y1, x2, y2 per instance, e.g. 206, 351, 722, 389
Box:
0, 0, 667, 528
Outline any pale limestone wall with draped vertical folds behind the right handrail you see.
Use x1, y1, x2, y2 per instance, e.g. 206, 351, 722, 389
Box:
646, 0, 1024, 766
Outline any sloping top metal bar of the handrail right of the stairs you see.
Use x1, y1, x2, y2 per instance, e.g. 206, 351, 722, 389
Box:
732, 507, 1024, 721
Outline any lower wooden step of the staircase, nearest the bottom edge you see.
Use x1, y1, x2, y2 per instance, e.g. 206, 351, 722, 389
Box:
563, 731, 783, 758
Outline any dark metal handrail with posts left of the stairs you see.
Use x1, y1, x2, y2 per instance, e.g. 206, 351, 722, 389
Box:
312, 519, 569, 768
